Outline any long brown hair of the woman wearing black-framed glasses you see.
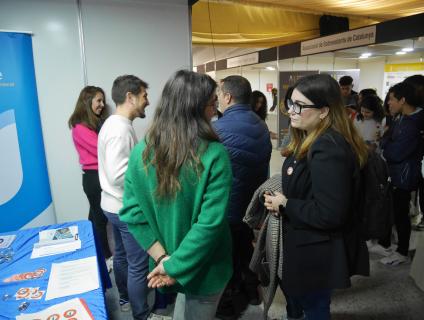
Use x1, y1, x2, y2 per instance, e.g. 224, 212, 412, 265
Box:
286, 74, 368, 168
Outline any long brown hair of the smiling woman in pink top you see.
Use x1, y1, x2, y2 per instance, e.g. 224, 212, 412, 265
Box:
68, 86, 107, 131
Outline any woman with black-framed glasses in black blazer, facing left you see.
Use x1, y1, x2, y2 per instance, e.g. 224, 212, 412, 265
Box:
265, 74, 369, 320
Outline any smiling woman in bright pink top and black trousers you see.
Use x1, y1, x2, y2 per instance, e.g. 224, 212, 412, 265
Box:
68, 86, 112, 269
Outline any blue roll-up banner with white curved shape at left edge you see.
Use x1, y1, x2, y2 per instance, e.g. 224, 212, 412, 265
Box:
0, 32, 56, 232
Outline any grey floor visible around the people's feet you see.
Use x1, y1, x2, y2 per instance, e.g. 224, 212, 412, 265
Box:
106, 236, 424, 320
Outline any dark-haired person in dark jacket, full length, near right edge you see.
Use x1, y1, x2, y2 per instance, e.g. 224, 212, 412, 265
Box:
380, 82, 424, 266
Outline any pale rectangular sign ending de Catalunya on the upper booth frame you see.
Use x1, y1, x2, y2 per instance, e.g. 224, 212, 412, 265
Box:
300, 26, 376, 56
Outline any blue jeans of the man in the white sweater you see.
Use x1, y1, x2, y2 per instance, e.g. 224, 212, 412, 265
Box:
104, 211, 150, 320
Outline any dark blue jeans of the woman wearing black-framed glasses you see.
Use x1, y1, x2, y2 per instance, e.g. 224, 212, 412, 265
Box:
284, 290, 331, 320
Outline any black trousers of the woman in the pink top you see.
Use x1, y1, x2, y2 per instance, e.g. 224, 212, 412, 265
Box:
82, 170, 112, 259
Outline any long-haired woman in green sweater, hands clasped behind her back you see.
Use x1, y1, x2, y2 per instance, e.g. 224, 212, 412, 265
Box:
119, 70, 232, 320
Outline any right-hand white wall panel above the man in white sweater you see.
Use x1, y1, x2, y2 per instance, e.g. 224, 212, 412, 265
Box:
82, 0, 191, 138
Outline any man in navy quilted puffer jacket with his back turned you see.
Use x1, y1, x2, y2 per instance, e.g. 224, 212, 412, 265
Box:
214, 76, 272, 319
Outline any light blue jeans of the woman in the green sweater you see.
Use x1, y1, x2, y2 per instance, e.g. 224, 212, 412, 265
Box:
172, 289, 224, 320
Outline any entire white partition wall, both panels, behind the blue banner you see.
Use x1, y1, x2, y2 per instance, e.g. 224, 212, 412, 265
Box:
0, 0, 191, 222
